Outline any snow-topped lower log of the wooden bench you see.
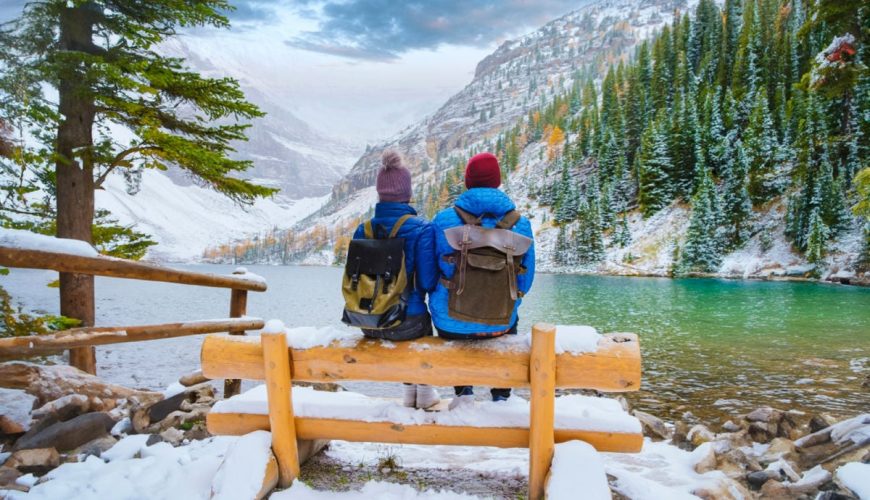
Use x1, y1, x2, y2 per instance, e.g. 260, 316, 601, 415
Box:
208, 386, 643, 451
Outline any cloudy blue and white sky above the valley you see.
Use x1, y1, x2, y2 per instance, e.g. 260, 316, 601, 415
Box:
0, 0, 588, 143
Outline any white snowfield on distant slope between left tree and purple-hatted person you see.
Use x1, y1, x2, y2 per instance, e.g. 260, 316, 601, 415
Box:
96, 170, 328, 261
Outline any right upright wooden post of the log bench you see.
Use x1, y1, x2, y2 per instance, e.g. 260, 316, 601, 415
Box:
529, 323, 556, 500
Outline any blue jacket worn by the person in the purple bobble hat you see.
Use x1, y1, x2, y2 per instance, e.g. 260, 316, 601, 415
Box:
353, 202, 438, 316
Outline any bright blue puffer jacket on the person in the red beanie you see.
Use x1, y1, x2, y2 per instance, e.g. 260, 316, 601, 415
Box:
429, 188, 535, 334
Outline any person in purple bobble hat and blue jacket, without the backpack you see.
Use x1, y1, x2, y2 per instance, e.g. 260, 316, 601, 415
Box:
353, 150, 440, 409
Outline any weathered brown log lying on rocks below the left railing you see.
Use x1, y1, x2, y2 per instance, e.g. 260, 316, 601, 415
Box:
0, 361, 163, 407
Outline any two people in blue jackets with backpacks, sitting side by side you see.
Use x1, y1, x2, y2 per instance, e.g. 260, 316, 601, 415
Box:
342, 151, 535, 409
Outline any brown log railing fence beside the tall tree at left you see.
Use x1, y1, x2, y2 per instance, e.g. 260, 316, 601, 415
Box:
0, 246, 266, 397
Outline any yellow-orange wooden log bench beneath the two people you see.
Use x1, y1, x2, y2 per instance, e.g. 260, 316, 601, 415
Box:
202, 324, 643, 498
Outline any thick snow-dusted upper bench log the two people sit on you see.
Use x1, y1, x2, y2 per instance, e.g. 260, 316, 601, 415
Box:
202, 321, 641, 392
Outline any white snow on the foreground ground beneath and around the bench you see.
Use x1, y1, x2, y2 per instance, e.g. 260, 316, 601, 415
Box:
0, 431, 768, 500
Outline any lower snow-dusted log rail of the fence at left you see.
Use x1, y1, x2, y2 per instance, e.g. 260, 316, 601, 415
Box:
0, 318, 264, 360
